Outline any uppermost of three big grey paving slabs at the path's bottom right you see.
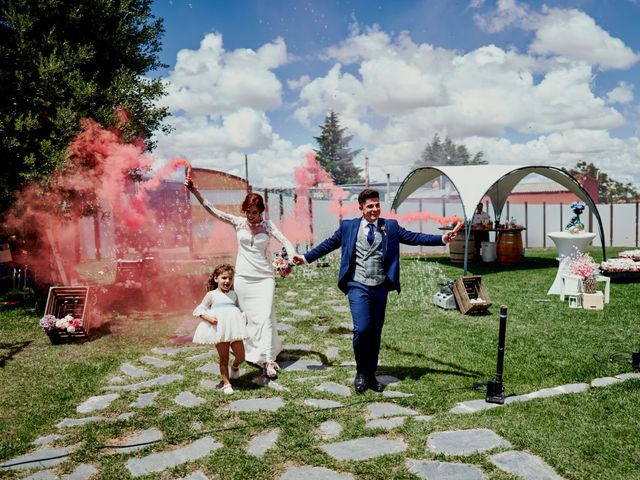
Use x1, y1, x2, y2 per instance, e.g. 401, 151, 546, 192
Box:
427, 428, 511, 455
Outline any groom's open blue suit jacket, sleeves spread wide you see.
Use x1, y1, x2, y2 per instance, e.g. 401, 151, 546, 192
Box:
304, 217, 444, 293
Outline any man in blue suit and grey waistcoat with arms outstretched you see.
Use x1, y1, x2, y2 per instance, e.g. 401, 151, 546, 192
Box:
293, 189, 455, 393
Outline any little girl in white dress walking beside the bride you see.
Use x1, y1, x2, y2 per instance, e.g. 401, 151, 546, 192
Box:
193, 263, 248, 394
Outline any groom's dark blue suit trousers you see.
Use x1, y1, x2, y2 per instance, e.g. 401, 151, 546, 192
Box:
347, 281, 389, 375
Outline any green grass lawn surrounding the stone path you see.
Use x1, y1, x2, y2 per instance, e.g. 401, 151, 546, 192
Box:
0, 249, 640, 479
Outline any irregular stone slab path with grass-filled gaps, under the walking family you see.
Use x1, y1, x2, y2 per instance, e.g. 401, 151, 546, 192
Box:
5, 280, 640, 480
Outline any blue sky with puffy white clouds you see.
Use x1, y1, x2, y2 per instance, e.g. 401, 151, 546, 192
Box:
153, 0, 640, 187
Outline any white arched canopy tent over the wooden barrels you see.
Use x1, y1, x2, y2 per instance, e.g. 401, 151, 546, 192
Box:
391, 165, 607, 275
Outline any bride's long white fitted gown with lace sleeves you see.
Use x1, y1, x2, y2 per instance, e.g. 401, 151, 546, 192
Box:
202, 199, 296, 364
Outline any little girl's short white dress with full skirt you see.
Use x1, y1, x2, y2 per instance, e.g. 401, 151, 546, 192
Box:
193, 289, 249, 343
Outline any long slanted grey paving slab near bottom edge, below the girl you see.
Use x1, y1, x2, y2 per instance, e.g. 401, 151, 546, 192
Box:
127, 437, 222, 477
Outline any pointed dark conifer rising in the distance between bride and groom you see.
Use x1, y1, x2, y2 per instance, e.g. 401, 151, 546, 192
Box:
313, 111, 363, 185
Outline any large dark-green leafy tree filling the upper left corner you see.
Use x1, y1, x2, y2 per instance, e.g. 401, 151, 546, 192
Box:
0, 0, 168, 212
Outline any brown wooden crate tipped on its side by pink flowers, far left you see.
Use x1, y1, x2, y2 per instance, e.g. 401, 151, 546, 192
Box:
44, 287, 91, 343
